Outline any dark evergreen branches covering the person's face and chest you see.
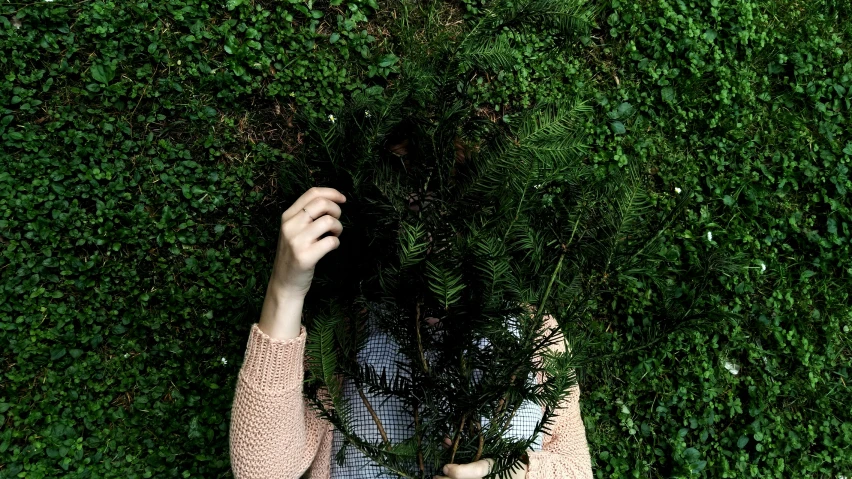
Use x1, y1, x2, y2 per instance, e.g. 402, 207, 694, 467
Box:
282, 0, 739, 478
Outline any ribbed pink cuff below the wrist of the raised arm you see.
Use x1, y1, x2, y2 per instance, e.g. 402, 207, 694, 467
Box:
240, 323, 307, 394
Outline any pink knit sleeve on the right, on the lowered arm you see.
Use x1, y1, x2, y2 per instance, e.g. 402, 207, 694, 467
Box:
527, 317, 593, 479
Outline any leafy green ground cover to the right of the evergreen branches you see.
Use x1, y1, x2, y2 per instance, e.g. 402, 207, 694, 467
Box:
460, 0, 852, 477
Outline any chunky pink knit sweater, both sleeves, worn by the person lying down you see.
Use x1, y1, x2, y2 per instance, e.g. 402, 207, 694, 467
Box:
230, 320, 592, 479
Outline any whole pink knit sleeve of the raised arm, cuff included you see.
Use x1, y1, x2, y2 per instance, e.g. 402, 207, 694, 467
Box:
229, 323, 332, 479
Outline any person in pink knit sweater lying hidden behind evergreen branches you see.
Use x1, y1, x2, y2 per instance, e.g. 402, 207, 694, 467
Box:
229, 187, 592, 479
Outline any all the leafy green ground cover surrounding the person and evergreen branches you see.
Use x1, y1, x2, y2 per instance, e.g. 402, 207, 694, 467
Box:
0, 0, 852, 478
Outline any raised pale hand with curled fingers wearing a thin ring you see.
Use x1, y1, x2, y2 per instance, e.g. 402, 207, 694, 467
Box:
269, 186, 346, 296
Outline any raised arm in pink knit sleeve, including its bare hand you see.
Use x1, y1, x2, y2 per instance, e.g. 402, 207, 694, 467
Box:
230, 187, 346, 479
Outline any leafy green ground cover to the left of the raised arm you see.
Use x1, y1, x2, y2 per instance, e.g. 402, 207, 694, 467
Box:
0, 1, 393, 478
